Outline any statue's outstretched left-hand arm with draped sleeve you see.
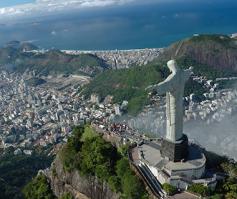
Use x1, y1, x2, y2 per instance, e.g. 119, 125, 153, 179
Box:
146, 74, 174, 95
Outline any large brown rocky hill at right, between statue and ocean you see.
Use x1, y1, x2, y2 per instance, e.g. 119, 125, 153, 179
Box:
163, 35, 237, 72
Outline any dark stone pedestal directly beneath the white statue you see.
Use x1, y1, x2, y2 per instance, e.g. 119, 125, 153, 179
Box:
161, 135, 188, 162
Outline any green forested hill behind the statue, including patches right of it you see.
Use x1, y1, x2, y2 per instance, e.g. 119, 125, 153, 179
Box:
84, 59, 211, 115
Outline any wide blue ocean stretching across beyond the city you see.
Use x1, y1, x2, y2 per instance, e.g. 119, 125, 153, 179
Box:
0, 0, 237, 50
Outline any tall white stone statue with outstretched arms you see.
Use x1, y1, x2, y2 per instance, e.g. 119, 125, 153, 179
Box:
147, 60, 192, 142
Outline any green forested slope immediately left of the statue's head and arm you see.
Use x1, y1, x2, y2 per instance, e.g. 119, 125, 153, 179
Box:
84, 61, 168, 113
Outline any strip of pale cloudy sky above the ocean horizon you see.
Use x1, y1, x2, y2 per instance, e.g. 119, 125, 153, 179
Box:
0, 0, 200, 22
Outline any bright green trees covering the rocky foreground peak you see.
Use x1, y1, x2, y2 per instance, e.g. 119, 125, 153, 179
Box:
24, 126, 148, 199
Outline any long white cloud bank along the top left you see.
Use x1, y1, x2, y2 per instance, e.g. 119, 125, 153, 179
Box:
0, 0, 135, 19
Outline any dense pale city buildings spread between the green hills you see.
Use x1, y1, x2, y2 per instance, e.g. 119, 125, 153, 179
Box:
0, 49, 237, 155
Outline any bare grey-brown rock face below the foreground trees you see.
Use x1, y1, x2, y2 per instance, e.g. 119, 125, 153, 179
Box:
44, 156, 119, 199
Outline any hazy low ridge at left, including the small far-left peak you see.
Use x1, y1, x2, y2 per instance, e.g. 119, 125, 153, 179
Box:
0, 41, 108, 76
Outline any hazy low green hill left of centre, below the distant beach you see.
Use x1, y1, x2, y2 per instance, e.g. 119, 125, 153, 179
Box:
15, 50, 106, 76
